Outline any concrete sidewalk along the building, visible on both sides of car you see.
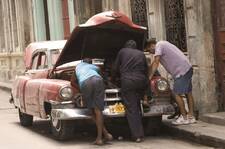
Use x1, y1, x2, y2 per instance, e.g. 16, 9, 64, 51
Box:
0, 82, 225, 149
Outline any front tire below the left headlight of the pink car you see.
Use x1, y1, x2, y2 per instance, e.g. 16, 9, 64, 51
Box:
51, 117, 74, 141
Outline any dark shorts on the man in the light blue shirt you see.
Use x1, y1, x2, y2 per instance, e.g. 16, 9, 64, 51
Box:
81, 76, 105, 111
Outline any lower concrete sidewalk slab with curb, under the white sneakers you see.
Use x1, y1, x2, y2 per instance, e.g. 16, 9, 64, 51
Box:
163, 120, 225, 149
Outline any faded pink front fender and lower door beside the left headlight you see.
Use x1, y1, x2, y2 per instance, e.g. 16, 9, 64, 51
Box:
25, 79, 78, 118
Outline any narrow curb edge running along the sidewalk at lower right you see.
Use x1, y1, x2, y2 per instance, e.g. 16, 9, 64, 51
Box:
163, 121, 225, 149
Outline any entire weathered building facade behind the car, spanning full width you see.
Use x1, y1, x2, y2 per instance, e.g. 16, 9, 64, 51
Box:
0, 0, 225, 114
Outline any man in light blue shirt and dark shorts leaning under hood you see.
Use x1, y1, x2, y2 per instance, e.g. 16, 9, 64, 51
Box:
72, 59, 113, 145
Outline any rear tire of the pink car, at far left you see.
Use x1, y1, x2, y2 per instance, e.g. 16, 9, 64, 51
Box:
19, 109, 33, 127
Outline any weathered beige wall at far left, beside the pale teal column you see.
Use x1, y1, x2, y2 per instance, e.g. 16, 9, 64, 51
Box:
0, 0, 34, 81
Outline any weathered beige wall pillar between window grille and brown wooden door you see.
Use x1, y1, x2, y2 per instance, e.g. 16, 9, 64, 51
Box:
184, 0, 218, 114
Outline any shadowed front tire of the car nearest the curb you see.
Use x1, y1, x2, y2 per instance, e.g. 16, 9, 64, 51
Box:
143, 116, 162, 136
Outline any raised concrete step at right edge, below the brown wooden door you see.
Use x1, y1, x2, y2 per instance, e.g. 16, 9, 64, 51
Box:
201, 112, 225, 126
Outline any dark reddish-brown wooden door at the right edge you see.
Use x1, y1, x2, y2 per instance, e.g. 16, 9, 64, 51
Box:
213, 0, 225, 110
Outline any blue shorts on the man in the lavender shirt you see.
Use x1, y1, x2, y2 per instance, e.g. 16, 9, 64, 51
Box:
173, 68, 193, 94
